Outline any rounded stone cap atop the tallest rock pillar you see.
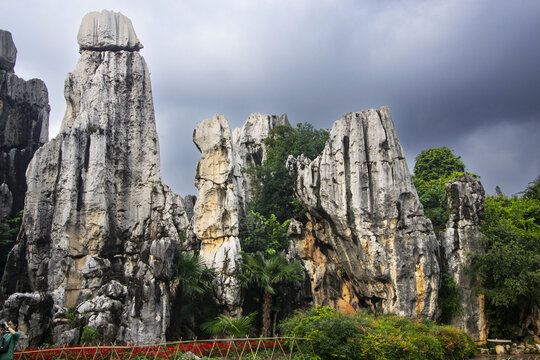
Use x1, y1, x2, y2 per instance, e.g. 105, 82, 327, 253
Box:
77, 10, 143, 51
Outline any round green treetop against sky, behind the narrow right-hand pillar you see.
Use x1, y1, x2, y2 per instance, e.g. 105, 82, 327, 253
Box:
414, 146, 465, 181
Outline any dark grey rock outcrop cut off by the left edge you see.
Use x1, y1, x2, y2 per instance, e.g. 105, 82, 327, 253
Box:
0, 30, 49, 220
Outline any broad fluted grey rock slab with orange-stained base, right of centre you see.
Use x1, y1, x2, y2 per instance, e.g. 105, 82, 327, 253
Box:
287, 107, 439, 317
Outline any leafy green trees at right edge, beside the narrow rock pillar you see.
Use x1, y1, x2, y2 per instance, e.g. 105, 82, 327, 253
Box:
472, 178, 540, 338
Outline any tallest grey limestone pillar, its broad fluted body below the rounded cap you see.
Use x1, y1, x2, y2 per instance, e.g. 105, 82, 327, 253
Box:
3, 12, 189, 344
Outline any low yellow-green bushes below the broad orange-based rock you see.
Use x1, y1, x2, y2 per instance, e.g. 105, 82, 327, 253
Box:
281, 307, 476, 360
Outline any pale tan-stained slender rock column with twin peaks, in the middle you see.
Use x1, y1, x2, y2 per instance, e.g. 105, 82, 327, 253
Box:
193, 113, 288, 314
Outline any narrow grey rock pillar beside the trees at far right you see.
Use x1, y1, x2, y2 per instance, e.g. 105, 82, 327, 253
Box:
441, 174, 488, 342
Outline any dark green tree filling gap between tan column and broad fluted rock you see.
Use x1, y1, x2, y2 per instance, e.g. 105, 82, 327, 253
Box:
247, 123, 329, 223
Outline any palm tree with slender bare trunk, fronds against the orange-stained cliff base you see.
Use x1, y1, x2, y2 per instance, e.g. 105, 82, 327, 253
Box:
239, 252, 302, 336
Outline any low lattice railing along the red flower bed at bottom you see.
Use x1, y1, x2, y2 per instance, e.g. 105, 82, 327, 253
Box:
14, 337, 314, 360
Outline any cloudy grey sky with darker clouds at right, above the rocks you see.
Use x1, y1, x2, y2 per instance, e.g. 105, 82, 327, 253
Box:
0, 0, 540, 196
